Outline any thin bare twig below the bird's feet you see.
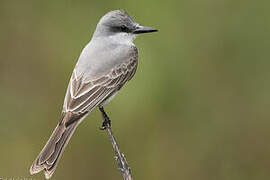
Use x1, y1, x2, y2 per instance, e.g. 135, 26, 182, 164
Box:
105, 123, 132, 180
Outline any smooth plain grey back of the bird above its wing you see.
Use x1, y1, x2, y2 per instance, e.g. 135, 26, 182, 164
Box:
75, 40, 134, 81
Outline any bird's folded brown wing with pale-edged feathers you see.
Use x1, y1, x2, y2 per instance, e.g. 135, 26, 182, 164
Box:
60, 47, 138, 125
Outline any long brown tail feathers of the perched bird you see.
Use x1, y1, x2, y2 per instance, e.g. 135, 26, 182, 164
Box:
30, 121, 79, 179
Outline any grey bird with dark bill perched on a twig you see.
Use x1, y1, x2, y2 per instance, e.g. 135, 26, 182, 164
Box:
30, 10, 157, 179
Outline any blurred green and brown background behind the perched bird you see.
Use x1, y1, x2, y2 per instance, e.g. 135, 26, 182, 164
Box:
0, 0, 270, 180
